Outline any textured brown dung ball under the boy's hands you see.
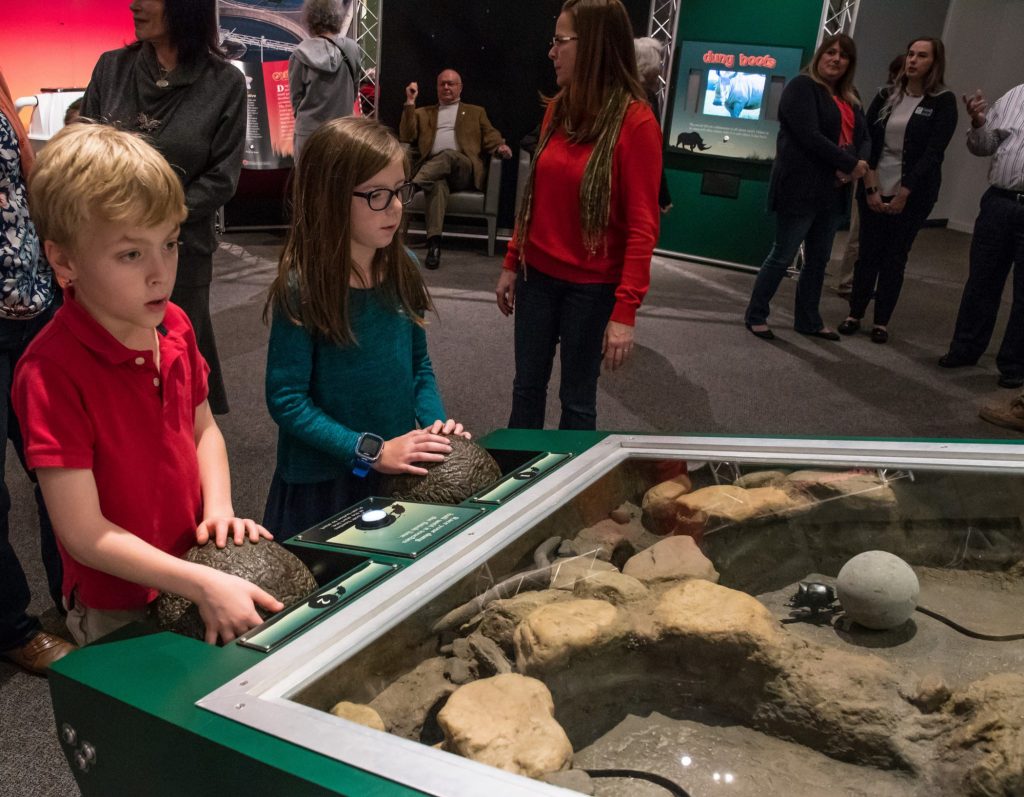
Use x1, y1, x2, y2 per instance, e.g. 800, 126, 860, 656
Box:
153, 540, 316, 639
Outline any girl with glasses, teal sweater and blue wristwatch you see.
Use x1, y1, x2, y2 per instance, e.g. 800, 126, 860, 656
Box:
263, 117, 470, 540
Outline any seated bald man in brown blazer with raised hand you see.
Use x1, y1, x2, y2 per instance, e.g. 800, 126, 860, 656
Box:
398, 70, 512, 268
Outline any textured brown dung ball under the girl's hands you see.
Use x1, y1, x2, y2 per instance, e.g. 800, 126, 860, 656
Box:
380, 436, 502, 504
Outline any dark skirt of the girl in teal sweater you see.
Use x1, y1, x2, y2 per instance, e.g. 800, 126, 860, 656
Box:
263, 470, 379, 542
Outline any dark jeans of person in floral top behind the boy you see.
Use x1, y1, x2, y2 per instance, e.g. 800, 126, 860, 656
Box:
0, 307, 61, 651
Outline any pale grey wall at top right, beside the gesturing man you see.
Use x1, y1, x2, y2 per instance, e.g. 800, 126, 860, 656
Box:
932, 0, 1024, 233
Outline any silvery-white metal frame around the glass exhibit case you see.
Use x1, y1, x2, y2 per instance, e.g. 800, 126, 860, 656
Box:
197, 435, 1024, 797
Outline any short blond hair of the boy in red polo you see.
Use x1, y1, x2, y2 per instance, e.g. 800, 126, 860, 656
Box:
29, 123, 188, 249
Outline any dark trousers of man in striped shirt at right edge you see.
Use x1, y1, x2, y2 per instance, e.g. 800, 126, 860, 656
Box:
949, 188, 1024, 377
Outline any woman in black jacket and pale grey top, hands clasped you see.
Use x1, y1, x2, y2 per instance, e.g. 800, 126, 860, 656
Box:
839, 39, 956, 343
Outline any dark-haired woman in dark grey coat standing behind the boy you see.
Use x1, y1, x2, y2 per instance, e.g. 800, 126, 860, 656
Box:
82, 0, 246, 414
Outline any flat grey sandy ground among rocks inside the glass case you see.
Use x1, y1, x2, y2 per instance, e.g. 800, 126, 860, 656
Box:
573, 568, 1024, 797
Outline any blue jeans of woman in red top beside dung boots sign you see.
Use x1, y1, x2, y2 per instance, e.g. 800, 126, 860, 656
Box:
744, 204, 840, 334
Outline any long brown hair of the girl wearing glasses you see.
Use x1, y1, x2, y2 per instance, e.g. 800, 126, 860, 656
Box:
263, 117, 433, 346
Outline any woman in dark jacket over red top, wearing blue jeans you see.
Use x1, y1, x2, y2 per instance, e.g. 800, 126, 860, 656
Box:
744, 34, 868, 340
